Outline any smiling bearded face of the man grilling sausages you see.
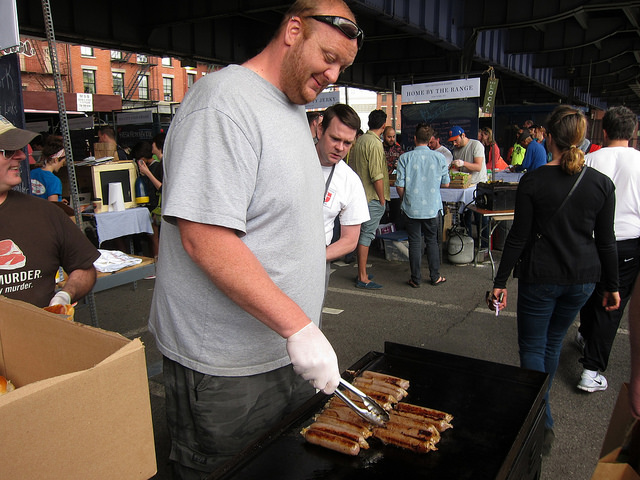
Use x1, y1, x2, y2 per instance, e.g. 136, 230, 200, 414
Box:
280, 13, 358, 105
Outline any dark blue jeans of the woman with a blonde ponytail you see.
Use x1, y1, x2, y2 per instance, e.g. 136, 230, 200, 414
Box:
518, 281, 595, 428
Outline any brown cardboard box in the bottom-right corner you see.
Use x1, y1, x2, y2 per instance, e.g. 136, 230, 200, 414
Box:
591, 383, 640, 480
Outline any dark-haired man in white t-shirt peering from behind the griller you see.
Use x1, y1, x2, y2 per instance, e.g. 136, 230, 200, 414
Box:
316, 103, 369, 262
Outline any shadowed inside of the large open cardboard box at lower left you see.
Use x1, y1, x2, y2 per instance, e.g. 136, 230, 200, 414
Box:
0, 297, 130, 387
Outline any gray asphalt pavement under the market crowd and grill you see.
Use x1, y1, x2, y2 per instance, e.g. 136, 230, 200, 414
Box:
76, 244, 630, 480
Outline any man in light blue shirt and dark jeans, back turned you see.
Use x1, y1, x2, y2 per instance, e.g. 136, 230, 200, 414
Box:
396, 126, 450, 288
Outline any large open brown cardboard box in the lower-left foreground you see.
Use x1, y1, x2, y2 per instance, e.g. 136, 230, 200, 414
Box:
0, 297, 156, 480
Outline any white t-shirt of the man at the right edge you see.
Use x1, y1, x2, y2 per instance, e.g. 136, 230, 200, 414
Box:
585, 147, 640, 241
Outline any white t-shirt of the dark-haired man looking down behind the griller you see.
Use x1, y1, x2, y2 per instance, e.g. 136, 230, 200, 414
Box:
322, 160, 370, 245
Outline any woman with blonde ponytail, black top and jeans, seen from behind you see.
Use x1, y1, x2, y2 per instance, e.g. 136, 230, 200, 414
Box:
488, 106, 620, 453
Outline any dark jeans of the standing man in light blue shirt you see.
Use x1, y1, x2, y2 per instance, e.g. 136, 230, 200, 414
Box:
403, 213, 440, 285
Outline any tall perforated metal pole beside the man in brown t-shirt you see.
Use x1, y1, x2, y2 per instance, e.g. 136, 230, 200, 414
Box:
41, 0, 98, 327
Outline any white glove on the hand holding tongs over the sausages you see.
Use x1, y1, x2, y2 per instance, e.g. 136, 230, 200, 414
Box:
287, 323, 340, 395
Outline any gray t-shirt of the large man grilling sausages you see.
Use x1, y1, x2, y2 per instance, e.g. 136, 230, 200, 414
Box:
149, 65, 326, 376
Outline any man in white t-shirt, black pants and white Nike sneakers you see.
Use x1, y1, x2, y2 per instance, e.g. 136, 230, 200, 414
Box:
576, 107, 640, 392
